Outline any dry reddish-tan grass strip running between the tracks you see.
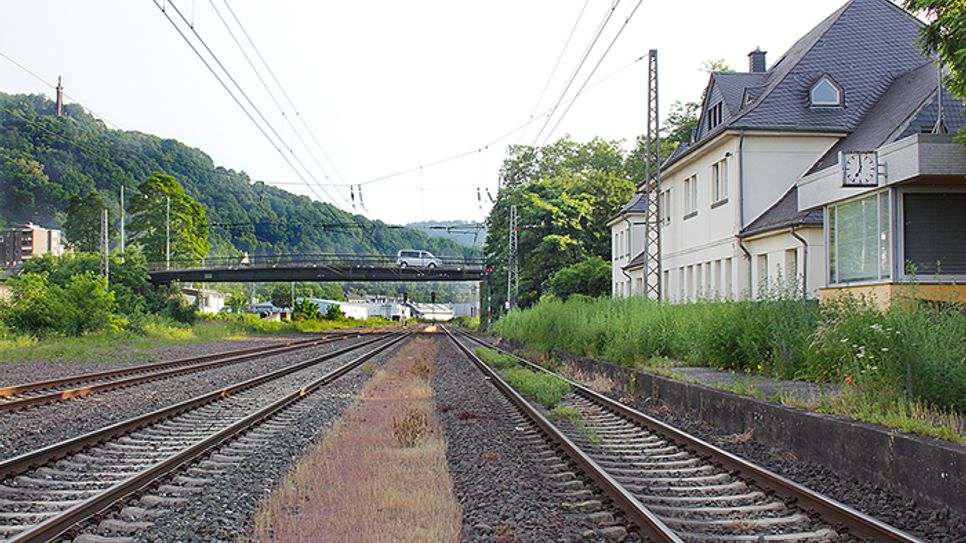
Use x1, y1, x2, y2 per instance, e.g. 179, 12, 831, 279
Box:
254, 336, 462, 542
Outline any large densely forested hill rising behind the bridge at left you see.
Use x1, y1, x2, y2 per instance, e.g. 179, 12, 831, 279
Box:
0, 93, 479, 256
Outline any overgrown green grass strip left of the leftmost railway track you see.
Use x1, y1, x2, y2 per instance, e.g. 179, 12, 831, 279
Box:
0, 314, 392, 362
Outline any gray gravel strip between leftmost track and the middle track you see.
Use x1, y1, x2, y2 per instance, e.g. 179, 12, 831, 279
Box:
0, 338, 370, 458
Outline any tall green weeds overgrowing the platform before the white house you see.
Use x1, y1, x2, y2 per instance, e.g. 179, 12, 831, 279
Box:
494, 298, 966, 412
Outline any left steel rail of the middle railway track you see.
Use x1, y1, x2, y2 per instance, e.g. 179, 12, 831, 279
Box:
0, 337, 394, 480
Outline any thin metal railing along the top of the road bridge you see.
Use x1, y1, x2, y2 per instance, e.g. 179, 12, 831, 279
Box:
148, 253, 486, 272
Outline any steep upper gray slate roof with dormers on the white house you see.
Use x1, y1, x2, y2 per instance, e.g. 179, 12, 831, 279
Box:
665, 0, 928, 167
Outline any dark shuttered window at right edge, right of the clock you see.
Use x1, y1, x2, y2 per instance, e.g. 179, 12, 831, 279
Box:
902, 192, 966, 278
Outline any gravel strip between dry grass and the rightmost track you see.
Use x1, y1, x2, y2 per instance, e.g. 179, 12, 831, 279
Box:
433, 337, 612, 542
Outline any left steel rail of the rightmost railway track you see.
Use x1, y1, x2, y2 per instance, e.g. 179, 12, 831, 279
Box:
442, 327, 683, 543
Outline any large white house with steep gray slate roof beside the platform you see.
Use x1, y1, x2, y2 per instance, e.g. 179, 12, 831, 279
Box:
611, 0, 930, 302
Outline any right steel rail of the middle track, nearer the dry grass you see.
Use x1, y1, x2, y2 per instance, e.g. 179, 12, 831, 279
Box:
9, 332, 412, 543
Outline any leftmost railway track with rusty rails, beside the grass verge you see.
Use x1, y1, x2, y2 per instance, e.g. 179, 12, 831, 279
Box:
0, 332, 378, 413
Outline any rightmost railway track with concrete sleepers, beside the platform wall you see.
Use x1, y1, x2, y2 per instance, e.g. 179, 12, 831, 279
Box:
446, 330, 920, 543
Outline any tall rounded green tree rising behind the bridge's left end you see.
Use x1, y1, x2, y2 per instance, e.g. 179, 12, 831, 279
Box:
128, 173, 211, 264
